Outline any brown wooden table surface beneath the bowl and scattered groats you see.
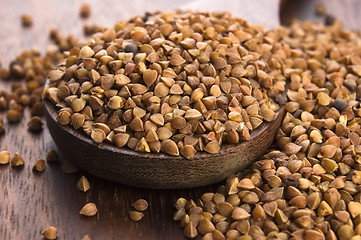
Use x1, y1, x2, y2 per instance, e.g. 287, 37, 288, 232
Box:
0, 0, 361, 240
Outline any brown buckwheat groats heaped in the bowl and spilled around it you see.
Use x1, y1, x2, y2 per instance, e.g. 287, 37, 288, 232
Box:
0, 7, 361, 240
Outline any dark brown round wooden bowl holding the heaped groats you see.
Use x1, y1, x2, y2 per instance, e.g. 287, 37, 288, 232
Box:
44, 96, 284, 189
